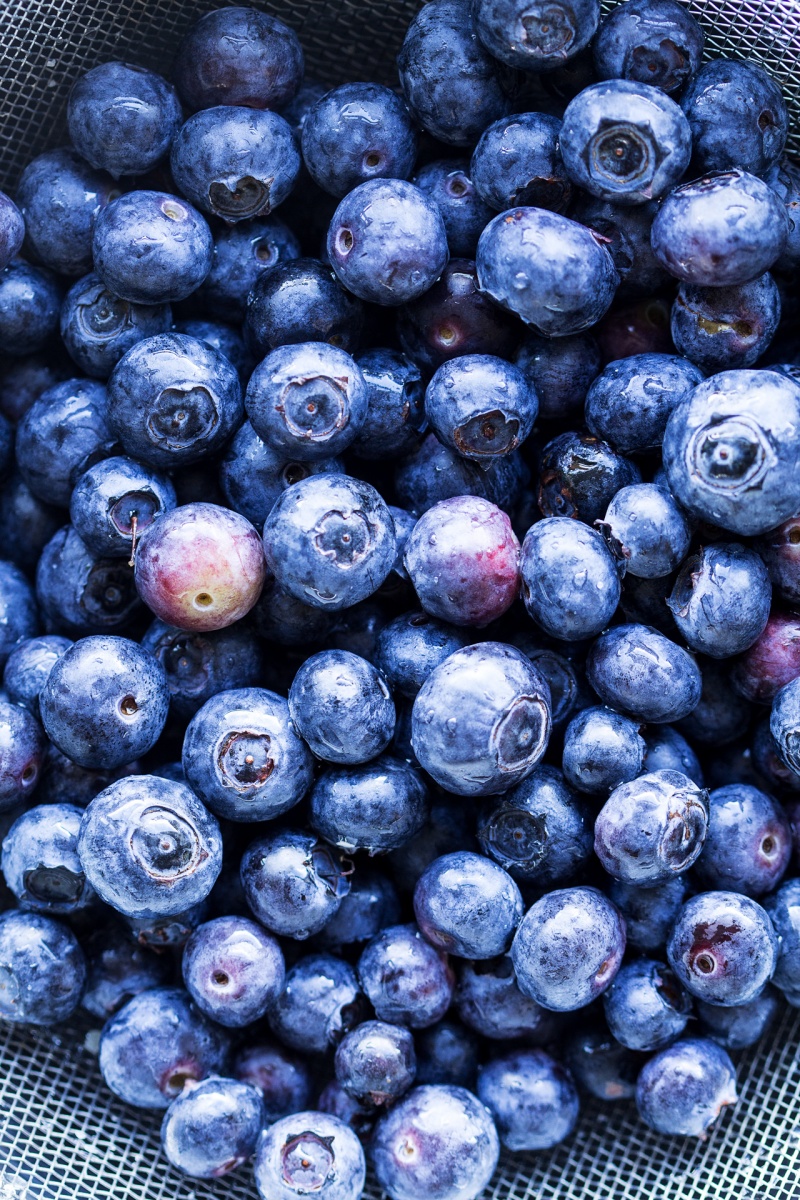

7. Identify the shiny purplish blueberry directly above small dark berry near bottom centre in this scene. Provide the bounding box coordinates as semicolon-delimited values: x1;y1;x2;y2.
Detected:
357;925;455;1030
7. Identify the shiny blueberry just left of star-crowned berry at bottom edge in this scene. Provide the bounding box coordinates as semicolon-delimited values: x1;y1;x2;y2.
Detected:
161;1075;264;1180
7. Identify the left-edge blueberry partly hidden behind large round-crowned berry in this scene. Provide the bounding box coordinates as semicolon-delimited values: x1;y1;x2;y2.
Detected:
2;804;94;917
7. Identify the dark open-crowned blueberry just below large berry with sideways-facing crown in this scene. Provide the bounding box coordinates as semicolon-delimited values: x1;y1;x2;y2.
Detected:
477;766;591;887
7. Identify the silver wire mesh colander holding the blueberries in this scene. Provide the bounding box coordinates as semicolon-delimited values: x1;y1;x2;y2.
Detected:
0;0;800;1200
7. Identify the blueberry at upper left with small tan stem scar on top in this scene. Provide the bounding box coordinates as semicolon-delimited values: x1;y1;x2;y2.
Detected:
92;192;213;304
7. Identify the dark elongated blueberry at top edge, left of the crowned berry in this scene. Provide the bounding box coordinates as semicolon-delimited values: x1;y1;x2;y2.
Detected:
397;0;511;146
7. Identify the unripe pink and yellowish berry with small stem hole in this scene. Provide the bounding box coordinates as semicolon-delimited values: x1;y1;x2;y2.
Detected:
134;503;266;632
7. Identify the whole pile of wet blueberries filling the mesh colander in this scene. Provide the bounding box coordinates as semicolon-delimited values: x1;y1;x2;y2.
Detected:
0;0;800;1200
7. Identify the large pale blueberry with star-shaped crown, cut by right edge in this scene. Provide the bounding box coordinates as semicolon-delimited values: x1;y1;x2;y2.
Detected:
663;371;800;536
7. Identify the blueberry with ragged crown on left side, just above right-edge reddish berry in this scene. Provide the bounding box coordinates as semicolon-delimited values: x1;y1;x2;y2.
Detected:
667;541;772;659
